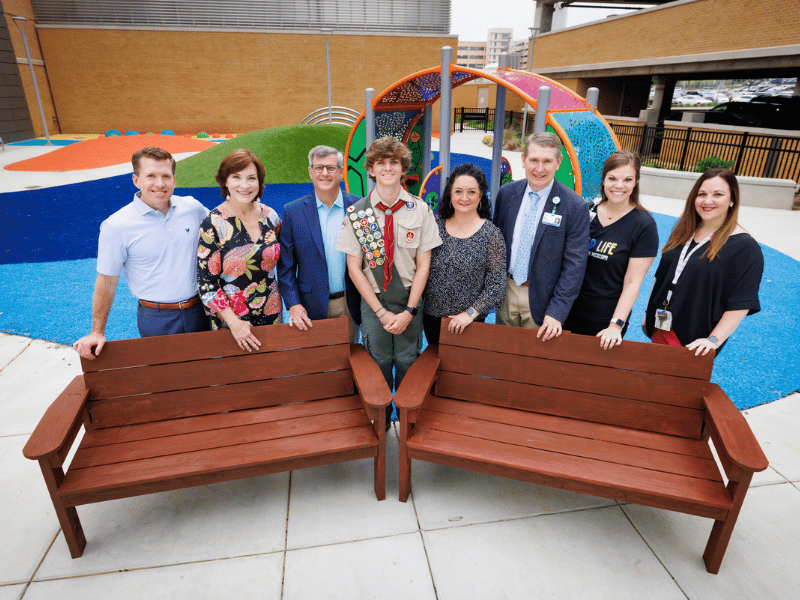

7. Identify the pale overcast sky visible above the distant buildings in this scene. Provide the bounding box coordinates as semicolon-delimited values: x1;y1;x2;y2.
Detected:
450;0;648;41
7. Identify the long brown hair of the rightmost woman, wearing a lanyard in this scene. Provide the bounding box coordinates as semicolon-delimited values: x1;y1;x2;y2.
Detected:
661;169;739;262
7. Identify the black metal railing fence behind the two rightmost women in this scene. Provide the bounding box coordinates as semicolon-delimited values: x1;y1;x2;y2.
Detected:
611;123;800;183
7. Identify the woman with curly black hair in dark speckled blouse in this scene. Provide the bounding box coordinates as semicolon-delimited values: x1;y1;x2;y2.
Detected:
422;164;506;344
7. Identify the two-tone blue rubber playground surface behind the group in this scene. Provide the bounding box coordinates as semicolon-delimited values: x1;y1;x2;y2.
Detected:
0;172;800;409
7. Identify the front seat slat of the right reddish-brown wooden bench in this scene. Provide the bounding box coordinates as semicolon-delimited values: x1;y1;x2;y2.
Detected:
408;428;733;519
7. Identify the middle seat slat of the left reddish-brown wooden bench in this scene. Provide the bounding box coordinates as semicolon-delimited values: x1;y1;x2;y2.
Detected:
70;407;370;469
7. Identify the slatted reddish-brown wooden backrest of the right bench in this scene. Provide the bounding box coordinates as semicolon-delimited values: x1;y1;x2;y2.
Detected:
434;319;713;439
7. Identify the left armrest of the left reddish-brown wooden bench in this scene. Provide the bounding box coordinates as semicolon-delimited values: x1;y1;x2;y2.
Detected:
22;375;89;466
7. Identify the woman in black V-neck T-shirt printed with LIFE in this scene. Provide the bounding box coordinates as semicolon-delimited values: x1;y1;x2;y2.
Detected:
564;150;658;350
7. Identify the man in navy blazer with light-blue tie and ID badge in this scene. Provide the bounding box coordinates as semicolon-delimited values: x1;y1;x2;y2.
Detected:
492;132;589;340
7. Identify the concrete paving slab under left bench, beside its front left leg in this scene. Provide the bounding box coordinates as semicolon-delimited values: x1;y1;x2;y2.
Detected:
36;473;289;580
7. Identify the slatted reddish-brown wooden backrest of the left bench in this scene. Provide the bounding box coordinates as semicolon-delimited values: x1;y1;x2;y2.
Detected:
81;317;354;428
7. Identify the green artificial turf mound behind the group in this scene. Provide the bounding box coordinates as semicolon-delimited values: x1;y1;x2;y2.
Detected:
175;125;350;188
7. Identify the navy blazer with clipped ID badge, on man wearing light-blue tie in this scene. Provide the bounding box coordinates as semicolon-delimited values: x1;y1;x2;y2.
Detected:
492;179;589;325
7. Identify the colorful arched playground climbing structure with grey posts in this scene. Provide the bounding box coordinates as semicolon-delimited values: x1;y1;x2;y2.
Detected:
345;46;619;207
